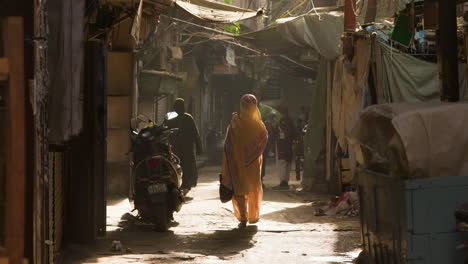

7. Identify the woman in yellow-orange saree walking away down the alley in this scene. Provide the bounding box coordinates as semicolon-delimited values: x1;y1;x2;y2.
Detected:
221;94;268;227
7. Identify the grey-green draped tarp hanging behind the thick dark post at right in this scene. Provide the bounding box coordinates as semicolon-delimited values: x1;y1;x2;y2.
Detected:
373;41;466;103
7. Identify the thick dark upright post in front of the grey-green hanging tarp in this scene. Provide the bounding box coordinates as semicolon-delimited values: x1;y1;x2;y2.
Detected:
438;0;460;102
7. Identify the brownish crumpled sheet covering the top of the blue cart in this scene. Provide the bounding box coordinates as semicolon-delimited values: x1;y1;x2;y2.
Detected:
352;103;468;178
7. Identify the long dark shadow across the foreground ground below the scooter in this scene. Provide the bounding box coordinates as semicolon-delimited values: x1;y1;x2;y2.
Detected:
65;226;258;263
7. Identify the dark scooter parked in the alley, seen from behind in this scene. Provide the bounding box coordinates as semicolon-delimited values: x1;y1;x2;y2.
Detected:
131;113;184;231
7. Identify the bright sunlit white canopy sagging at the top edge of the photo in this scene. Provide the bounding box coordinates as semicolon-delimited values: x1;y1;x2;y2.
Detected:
175;0;263;23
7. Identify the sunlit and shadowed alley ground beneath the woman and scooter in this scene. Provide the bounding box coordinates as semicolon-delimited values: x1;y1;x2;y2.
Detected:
65;166;360;264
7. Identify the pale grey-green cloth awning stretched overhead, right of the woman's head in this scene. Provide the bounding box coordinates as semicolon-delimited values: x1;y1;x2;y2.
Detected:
237;12;344;60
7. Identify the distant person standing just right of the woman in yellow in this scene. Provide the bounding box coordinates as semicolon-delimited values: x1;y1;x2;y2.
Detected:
273;105;296;189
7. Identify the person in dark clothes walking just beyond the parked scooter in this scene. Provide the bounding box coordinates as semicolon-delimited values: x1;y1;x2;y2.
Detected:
167;98;202;194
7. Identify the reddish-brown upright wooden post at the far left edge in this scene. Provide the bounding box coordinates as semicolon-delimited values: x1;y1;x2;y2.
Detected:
3;17;27;264
